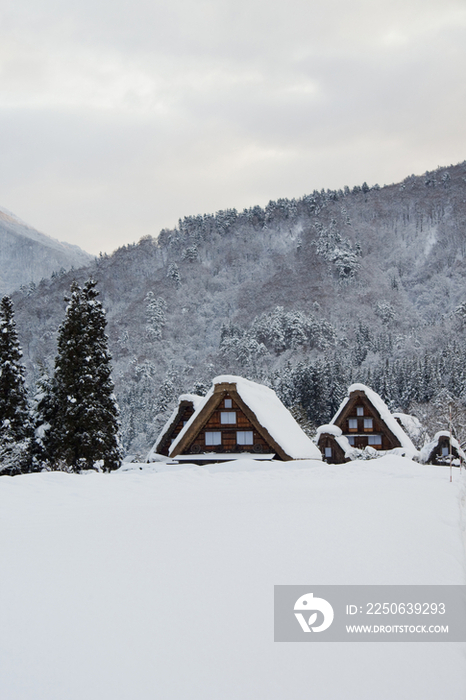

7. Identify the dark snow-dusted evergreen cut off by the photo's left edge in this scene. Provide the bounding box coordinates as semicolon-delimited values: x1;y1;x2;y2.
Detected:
0;296;32;474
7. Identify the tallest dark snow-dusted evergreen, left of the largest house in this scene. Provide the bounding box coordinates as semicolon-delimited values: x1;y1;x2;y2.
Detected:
44;280;121;471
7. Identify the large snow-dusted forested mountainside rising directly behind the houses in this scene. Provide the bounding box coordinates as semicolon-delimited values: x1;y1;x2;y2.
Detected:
14;162;466;450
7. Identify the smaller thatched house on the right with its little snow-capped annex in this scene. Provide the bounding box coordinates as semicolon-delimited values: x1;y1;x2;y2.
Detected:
318;384;418;464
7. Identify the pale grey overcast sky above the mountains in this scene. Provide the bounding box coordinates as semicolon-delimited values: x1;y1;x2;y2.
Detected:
0;0;466;253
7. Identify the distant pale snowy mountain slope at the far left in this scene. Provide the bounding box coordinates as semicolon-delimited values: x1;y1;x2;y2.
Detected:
0;209;92;294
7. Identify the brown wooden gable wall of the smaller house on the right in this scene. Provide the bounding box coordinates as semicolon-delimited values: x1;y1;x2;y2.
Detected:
335;391;401;450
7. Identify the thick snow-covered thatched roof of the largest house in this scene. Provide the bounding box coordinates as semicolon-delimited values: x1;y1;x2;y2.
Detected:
169;374;322;460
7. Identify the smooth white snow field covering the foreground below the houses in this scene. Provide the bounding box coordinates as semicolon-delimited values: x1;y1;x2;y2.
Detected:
0;456;466;700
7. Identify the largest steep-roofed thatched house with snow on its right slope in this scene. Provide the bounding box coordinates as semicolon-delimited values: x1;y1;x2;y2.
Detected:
169;375;321;464
